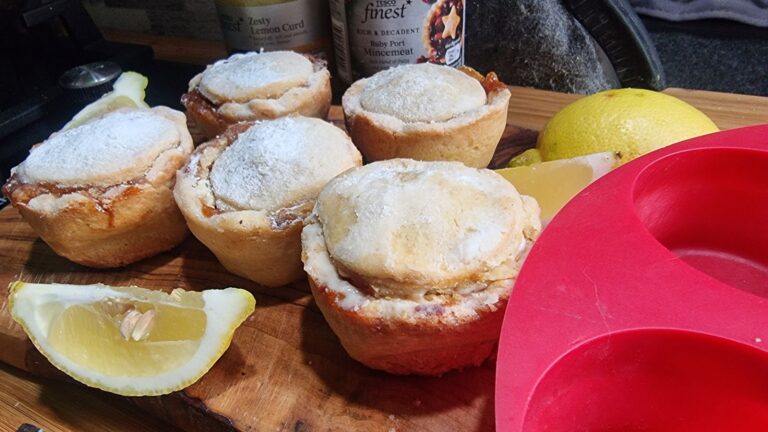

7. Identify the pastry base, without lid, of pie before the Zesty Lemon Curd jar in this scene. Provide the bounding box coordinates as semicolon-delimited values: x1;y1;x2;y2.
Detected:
181;58;331;140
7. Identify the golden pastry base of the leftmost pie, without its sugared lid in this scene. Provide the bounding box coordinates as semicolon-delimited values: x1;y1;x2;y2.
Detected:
4;108;192;268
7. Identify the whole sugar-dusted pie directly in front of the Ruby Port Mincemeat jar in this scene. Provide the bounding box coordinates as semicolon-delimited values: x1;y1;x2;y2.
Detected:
342;63;510;168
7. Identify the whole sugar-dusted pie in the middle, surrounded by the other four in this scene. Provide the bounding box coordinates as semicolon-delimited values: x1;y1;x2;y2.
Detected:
174;117;362;286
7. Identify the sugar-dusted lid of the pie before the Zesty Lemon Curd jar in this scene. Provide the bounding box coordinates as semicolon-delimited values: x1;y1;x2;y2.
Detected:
200;51;313;104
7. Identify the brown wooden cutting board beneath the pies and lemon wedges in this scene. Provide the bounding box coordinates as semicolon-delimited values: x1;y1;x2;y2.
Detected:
0;87;768;432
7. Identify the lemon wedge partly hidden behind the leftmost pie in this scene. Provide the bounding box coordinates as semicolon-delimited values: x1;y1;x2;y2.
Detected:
62;71;149;130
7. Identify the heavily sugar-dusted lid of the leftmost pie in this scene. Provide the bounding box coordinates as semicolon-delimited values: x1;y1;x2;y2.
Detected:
16;110;180;186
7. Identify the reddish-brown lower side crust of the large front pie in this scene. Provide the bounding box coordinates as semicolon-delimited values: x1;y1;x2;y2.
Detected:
309;274;513;376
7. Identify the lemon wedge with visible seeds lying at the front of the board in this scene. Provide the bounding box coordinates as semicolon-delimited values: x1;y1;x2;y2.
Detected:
10;282;255;396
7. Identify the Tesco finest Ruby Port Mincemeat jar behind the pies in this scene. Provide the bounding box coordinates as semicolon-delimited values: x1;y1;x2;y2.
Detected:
331;0;466;82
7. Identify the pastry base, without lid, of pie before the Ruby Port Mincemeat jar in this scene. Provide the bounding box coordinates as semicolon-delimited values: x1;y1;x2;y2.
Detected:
342;79;511;168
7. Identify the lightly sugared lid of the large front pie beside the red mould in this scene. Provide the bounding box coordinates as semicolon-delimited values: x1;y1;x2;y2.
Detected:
316;160;537;280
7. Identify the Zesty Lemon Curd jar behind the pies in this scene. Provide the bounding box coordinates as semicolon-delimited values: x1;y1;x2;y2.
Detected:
216;0;331;58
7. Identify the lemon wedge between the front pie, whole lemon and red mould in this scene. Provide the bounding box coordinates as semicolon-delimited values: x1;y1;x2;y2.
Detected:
496;152;619;223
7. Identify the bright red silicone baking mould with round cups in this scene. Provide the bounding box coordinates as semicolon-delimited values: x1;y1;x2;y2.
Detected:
496;125;768;432
